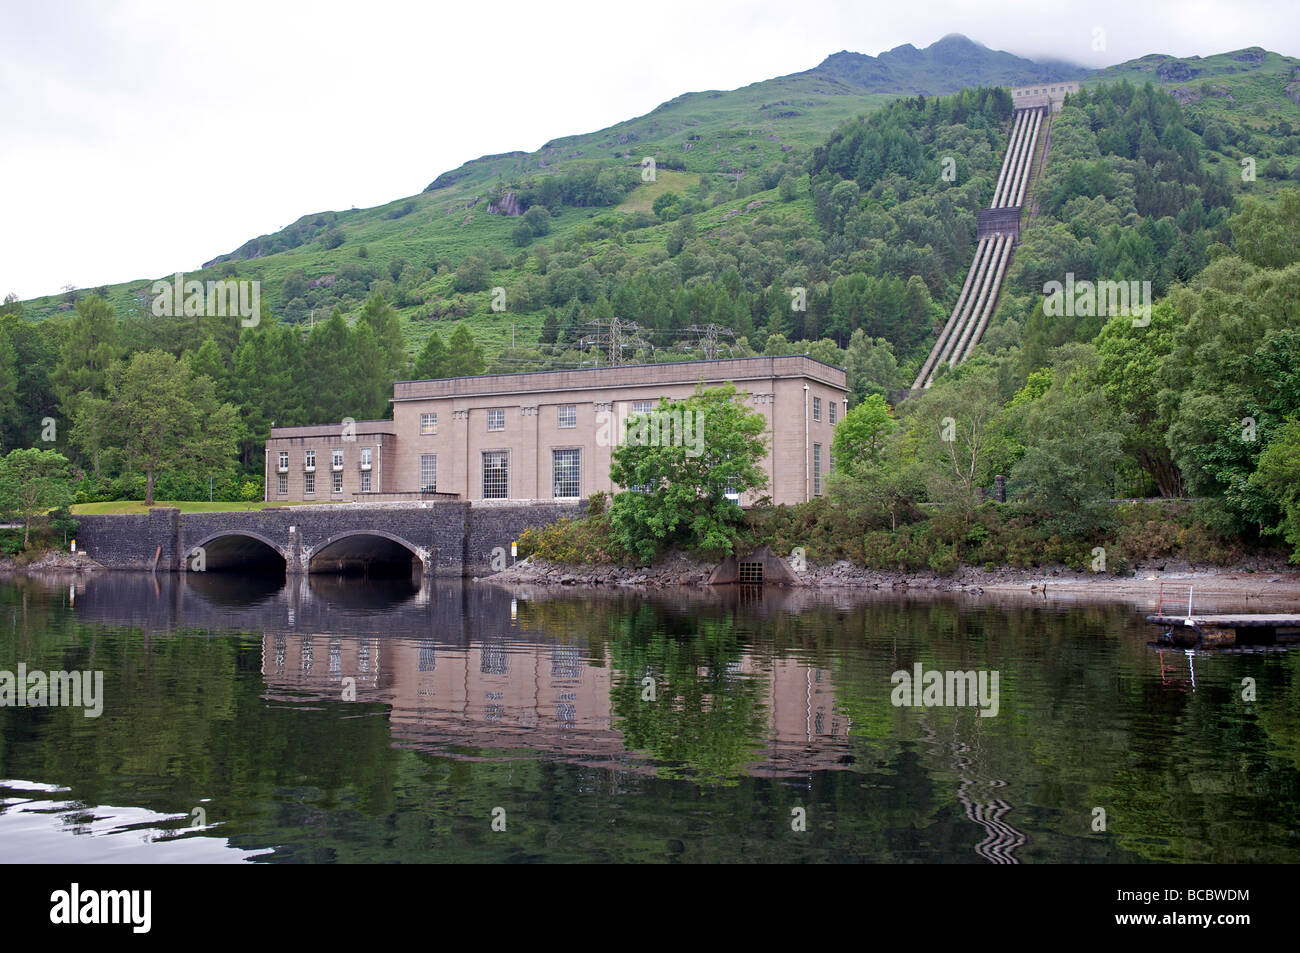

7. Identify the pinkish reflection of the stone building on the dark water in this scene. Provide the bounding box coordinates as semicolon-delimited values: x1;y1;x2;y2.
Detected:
263;632;850;775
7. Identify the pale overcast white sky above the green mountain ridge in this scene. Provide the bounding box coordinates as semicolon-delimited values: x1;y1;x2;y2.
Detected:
0;0;1300;298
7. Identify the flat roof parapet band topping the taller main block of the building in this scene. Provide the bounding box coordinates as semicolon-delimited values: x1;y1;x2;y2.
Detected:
393;354;848;402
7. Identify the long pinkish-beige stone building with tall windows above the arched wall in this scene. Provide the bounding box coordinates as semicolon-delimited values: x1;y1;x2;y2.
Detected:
267;355;848;503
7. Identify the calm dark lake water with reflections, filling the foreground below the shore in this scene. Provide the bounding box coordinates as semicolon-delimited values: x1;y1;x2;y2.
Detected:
0;573;1300;863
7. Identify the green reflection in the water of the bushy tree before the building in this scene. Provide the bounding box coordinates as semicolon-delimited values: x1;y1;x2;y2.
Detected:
610;605;767;784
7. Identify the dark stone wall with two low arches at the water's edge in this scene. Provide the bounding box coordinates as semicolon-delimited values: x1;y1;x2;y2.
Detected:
77;501;581;576
